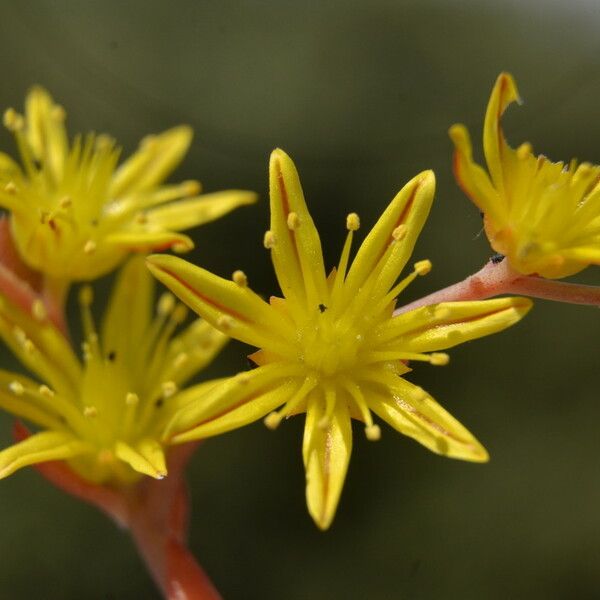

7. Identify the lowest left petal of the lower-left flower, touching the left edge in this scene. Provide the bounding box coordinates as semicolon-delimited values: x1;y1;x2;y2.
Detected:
0;431;90;479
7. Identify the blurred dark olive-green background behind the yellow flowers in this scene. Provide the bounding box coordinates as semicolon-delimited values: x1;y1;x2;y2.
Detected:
0;0;600;600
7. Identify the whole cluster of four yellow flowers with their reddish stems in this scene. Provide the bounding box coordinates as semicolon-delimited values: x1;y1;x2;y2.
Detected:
0;73;600;598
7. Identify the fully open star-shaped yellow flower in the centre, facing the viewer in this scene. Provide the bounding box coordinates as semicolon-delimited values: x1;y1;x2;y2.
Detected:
148;150;531;529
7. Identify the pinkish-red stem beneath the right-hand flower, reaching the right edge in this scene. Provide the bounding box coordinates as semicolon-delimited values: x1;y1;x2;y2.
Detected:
394;259;600;315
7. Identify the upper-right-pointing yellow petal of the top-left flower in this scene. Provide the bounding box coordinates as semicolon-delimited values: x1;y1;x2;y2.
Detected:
109;125;192;198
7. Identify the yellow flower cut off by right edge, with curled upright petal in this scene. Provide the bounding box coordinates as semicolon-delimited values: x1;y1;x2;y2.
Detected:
450;73;600;279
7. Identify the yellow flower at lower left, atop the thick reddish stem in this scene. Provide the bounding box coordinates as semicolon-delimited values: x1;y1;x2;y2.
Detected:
0;257;227;484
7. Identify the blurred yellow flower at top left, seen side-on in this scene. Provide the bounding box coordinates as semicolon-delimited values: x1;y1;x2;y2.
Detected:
0;87;255;281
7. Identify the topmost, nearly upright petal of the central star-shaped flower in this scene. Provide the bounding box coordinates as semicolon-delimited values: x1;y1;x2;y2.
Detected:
269;149;327;306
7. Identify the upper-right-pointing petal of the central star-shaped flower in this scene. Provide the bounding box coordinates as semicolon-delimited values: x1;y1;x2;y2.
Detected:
344;171;435;299
